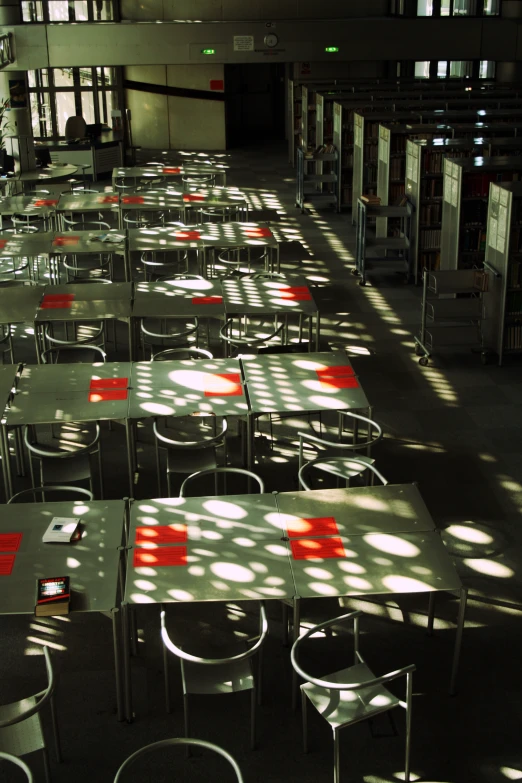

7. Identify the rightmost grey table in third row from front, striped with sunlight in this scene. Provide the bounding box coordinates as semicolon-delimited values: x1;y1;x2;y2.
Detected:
219;275;321;351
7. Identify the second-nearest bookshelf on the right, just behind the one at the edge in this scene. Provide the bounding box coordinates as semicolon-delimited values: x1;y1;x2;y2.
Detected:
440;155;522;269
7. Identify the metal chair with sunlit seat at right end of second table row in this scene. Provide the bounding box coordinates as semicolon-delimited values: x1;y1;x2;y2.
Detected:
298;411;386;489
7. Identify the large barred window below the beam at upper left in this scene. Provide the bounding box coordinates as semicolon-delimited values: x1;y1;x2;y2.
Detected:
28;67;118;138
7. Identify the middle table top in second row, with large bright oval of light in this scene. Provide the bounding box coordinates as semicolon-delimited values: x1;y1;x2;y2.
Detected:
129;359;248;419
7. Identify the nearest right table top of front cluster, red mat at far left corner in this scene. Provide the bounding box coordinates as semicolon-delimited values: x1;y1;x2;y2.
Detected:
290;532;462;598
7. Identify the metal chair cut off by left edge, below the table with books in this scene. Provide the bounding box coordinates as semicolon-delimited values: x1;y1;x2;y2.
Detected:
0;647;62;783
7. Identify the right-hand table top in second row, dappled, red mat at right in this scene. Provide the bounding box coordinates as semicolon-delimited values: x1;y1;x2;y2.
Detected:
241;351;369;413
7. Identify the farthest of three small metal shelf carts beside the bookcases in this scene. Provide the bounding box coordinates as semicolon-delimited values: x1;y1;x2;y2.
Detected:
295;145;339;213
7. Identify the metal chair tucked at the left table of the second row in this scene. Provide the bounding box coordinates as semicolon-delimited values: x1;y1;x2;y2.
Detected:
24;422;103;498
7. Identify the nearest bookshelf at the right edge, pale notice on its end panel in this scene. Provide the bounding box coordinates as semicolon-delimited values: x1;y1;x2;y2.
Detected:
484;182;522;365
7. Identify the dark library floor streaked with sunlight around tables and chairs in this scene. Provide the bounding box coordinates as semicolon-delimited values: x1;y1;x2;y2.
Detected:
0;144;522;783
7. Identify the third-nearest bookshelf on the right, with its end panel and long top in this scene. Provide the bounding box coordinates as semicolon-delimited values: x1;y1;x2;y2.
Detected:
405;137;522;283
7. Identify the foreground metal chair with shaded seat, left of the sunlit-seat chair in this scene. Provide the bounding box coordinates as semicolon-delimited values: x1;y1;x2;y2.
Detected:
161;602;268;749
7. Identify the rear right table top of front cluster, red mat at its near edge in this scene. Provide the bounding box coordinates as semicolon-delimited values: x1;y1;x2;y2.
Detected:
276;484;435;537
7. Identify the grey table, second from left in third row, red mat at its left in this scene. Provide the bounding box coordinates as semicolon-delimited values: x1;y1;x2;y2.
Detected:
34;283;134;364
